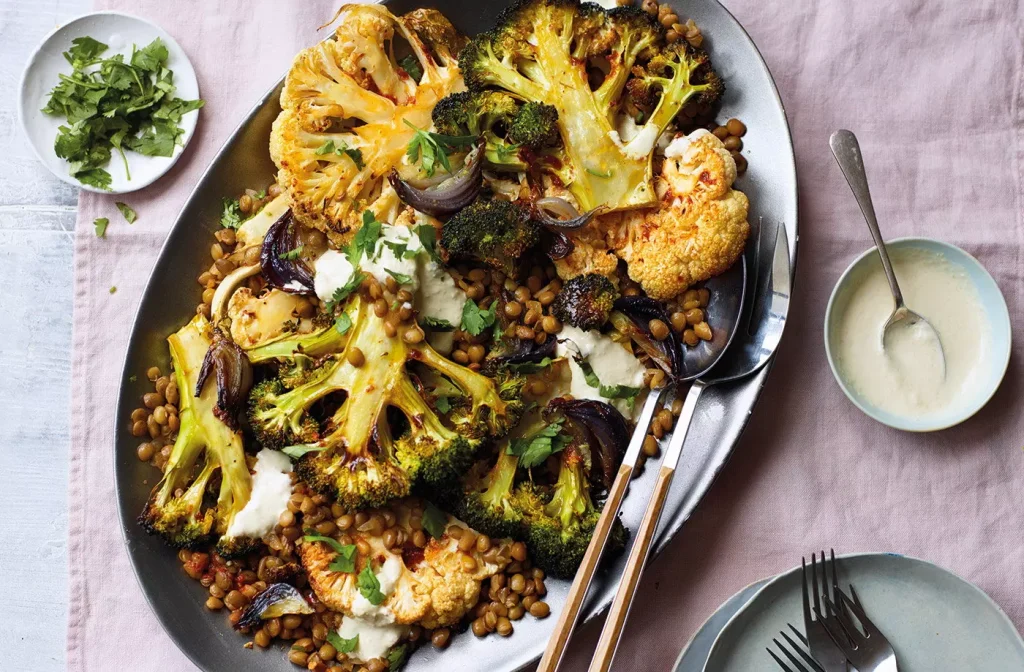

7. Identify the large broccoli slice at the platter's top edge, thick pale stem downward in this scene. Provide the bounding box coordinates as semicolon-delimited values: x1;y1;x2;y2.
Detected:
459;0;722;210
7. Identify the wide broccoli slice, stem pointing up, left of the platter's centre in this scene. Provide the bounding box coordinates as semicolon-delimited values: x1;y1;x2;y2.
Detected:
249;294;522;508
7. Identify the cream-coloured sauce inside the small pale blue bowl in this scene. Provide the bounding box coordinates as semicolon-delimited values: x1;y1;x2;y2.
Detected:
836;249;990;417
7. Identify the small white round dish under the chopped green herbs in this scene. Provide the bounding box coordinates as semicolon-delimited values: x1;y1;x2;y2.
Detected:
18;11;200;194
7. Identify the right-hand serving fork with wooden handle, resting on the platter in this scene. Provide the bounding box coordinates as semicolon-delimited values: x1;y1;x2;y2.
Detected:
590;224;791;672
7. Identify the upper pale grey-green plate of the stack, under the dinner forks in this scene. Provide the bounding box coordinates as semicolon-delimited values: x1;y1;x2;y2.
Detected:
704;553;1024;672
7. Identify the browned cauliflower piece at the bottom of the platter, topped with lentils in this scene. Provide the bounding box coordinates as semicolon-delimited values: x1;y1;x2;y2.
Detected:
299;502;508;628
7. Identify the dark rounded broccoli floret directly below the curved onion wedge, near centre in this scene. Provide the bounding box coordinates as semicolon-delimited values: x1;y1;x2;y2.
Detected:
441;199;541;277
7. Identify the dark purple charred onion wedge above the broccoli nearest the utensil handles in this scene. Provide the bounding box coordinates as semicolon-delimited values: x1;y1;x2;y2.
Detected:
548;396;630;489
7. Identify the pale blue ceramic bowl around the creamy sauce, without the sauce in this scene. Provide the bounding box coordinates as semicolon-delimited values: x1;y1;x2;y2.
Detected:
824;238;1011;431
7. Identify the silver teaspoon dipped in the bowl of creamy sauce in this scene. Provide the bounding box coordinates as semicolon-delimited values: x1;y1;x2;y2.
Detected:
828;130;946;379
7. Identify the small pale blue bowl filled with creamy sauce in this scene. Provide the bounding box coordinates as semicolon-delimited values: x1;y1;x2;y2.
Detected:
824;238;1011;431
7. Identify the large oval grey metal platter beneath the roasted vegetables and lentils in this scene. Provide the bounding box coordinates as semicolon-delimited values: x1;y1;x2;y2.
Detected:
115;0;797;672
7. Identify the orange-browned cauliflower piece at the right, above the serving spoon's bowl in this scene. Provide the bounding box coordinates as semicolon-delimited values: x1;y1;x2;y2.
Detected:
601;130;750;300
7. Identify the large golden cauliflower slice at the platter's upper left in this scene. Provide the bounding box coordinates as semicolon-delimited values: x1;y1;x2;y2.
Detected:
270;5;463;247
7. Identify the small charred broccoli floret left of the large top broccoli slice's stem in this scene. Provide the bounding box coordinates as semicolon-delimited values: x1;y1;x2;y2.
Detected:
433;91;560;172
